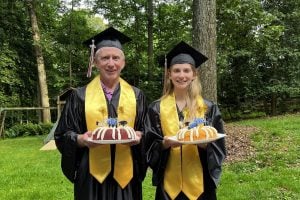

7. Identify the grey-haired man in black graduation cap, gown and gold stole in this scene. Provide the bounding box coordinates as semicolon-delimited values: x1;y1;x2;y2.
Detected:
55;27;147;200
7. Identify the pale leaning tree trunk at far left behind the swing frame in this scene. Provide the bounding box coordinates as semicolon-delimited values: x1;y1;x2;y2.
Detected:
27;0;51;123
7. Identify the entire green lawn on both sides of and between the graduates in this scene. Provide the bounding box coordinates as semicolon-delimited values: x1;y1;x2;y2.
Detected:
0;114;300;200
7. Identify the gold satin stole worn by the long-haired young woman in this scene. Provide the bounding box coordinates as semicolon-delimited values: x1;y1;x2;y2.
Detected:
160;94;205;199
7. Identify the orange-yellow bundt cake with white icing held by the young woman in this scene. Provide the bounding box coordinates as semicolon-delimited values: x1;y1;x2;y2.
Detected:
176;118;218;142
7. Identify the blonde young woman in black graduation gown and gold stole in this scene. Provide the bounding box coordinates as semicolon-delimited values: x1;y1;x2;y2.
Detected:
145;41;226;200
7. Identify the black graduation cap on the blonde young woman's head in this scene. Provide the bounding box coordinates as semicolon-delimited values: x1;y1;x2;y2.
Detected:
159;41;208;68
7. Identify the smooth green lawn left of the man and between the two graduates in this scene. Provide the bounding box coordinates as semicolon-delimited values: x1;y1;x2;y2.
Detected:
0;136;154;200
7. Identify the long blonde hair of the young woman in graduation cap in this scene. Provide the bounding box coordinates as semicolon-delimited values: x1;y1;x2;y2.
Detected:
161;65;207;121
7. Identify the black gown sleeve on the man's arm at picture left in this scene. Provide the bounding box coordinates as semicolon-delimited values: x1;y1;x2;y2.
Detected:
54;88;87;182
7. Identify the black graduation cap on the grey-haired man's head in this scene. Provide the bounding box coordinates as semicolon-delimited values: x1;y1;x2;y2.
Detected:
83;27;131;52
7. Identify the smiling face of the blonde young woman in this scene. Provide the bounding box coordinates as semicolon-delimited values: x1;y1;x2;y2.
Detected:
169;63;196;90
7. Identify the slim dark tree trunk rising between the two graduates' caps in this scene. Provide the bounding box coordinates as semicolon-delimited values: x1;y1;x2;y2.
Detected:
148;0;153;81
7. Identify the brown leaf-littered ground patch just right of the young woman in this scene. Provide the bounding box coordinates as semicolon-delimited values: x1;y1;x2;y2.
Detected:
225;124;258;163
